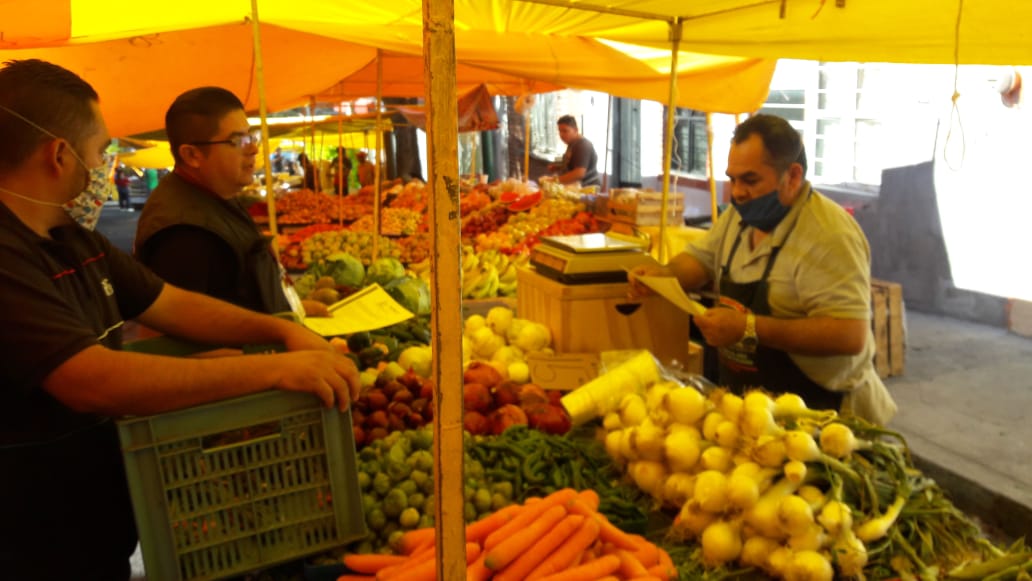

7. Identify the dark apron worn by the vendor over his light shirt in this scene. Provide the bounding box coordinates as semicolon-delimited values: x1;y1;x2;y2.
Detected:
719;226;843;410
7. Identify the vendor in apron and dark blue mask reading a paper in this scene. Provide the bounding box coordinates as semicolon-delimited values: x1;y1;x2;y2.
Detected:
632;115;896;423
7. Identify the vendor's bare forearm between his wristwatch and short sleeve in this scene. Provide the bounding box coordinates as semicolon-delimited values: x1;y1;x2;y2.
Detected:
756;316;869;356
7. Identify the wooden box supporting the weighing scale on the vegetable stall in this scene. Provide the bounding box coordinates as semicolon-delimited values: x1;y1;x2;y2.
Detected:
516;268;694;364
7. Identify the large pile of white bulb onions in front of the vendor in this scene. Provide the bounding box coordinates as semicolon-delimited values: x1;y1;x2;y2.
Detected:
603;382;904;581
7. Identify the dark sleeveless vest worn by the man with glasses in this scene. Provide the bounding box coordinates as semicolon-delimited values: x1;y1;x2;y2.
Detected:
134;172;291;314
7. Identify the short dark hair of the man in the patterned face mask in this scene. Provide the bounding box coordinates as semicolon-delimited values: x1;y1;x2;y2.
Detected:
0;59;100;169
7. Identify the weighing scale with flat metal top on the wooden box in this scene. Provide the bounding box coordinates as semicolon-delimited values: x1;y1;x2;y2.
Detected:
530;232;658;285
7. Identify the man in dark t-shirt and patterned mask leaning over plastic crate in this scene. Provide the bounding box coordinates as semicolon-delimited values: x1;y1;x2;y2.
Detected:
0;60;360;581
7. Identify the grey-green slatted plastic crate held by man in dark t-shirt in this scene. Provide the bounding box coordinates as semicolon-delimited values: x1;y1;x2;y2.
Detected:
118;338;365;581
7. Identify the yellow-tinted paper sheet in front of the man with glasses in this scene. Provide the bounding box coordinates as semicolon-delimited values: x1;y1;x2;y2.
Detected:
304;285;414;336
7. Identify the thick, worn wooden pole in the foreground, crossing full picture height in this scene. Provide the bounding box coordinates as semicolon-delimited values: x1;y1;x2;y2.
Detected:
423;0;465;580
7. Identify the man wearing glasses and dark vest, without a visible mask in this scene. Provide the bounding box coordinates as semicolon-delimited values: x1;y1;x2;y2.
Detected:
135;87;296;314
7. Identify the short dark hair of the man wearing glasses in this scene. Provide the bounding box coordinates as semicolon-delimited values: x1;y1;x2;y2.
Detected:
165;87;244;163
